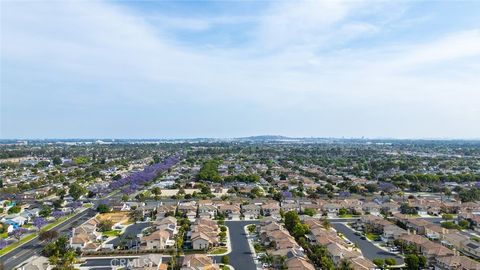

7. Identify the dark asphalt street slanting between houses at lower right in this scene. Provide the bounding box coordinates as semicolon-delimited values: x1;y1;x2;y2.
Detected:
332;223;403;264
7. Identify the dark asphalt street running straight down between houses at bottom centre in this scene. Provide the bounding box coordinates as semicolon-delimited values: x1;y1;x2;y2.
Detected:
213;220;258;270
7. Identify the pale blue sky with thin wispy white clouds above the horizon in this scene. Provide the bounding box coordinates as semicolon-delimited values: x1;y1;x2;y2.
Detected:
0;0;480;138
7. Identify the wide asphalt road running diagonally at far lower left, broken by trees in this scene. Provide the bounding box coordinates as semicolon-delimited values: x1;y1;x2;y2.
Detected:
0;209;95;269
